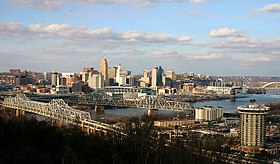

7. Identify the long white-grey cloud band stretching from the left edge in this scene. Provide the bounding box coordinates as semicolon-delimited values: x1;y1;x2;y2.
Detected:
0;23;191;46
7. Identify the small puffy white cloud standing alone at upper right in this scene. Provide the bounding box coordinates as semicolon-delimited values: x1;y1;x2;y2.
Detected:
209;27;244;37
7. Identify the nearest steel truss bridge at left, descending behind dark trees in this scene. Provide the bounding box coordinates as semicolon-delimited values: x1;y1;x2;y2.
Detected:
3;94;119;133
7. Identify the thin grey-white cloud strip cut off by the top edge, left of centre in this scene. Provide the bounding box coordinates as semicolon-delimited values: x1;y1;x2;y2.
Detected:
11;0;206;10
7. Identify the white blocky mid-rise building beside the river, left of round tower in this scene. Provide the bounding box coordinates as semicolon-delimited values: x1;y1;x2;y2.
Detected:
195;106;224;122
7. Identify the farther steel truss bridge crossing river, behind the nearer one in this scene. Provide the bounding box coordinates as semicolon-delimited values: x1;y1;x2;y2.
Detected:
75;91;193;111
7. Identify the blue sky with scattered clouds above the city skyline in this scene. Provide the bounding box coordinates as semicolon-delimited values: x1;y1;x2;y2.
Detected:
0;0;280;76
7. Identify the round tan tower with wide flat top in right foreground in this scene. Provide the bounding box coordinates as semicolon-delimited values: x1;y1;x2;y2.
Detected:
237;104;269;152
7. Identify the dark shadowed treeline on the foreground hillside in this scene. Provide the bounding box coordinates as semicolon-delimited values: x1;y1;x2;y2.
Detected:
0;117;223;164
